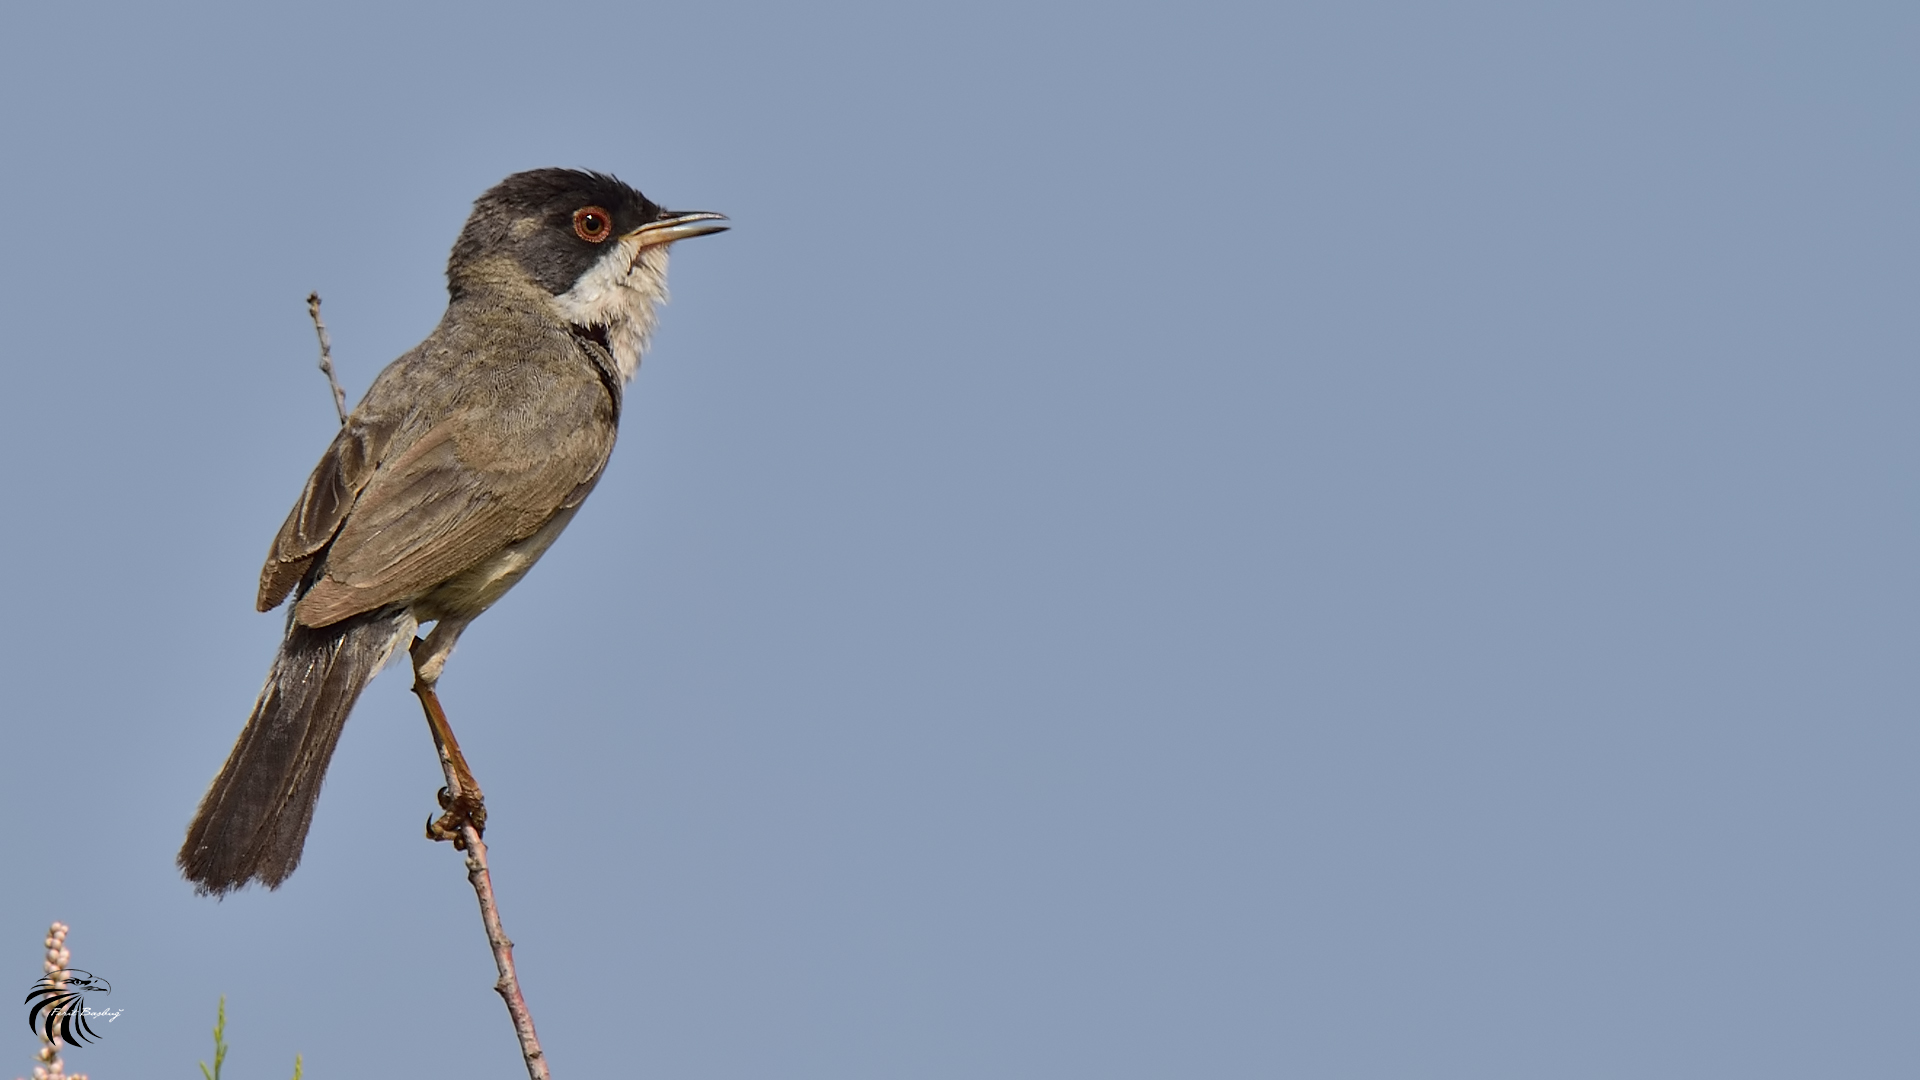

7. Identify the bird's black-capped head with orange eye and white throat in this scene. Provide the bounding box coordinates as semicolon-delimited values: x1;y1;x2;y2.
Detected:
447;169;726;379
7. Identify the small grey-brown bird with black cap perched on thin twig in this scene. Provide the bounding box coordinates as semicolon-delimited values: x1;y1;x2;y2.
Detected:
179;169;726;896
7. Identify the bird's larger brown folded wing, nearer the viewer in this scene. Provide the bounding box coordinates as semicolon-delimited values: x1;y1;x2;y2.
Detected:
296;401;614;626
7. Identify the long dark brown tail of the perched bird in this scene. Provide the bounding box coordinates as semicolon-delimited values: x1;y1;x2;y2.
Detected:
179;609;415;896
